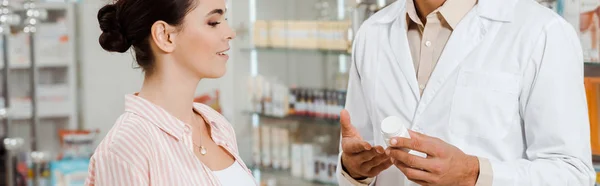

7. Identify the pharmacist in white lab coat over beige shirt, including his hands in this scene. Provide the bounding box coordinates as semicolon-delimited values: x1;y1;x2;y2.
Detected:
338;0;595;186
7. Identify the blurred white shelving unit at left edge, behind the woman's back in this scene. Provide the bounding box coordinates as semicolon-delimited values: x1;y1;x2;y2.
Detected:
0;2;78;154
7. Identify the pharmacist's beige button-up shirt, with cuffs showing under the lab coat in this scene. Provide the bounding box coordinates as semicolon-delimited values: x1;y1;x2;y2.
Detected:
342;0;493;186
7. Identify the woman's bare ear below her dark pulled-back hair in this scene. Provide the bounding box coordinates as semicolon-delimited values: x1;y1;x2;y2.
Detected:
150;21;177;53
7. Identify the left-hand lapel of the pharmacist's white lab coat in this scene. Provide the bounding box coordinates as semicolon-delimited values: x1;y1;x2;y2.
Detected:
389;12;420;100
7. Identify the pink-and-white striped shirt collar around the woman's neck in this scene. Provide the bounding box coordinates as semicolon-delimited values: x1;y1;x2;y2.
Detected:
125;93;217;140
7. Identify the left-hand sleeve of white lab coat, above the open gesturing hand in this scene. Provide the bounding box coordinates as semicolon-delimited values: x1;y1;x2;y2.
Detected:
336;25;375;186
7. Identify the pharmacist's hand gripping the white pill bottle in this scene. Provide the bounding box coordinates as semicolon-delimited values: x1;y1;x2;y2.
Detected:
386;130;479;186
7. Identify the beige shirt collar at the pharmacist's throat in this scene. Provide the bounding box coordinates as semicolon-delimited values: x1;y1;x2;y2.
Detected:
406;0;477;29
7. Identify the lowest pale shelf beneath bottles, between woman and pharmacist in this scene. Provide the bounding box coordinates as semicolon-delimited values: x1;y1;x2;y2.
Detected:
253;169;335;186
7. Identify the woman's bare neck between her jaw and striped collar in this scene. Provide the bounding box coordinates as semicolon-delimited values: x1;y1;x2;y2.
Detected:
138;62;200;124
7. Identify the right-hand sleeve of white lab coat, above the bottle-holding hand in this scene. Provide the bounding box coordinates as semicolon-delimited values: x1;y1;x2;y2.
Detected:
491;18;595;186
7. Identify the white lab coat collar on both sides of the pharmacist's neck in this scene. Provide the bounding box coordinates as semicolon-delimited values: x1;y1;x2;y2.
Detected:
373;0;518;24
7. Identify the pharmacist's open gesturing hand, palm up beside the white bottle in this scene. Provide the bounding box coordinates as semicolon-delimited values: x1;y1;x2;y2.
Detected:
340;110;392;179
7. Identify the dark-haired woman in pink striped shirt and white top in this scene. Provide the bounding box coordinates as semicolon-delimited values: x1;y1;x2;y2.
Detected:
86;0;256;186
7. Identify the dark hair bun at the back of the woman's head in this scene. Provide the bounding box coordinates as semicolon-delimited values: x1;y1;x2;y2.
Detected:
98;4;131;53
